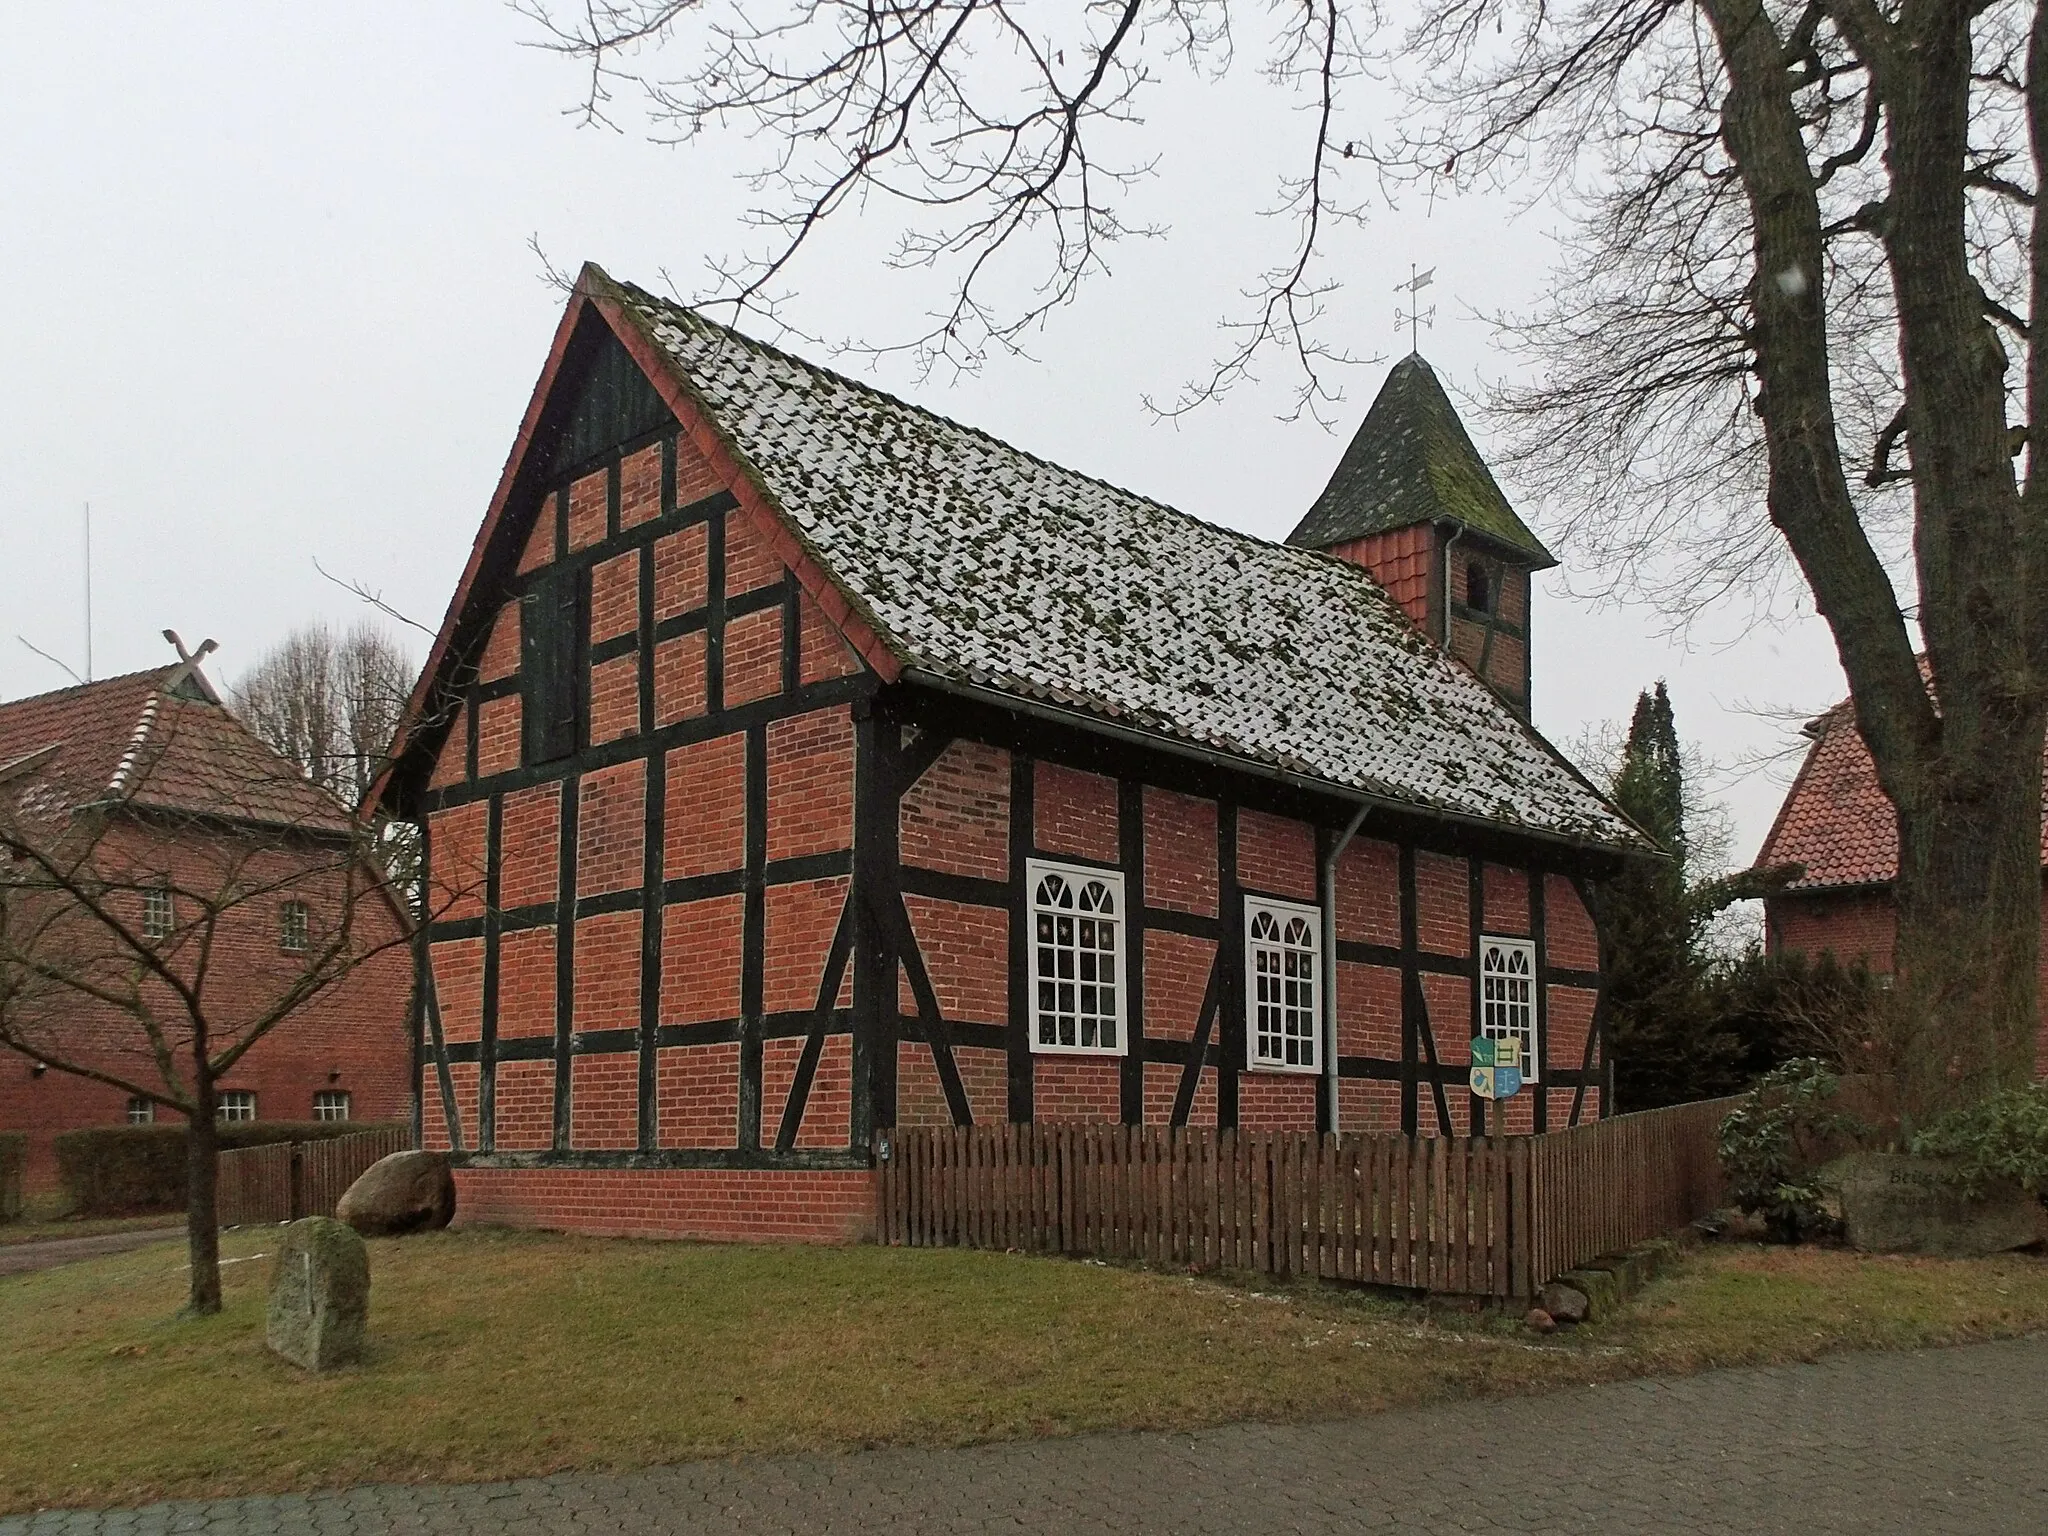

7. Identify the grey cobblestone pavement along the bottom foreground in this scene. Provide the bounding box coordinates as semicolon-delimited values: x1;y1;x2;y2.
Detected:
0;1337;2048;1536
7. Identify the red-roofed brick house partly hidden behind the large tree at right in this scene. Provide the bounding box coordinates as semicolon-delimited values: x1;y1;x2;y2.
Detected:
1757;684;2048;1075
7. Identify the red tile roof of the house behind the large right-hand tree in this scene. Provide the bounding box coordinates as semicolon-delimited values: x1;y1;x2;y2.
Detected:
1757;700;2048;891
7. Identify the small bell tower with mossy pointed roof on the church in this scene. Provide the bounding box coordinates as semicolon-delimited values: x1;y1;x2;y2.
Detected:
1286;352;1556;719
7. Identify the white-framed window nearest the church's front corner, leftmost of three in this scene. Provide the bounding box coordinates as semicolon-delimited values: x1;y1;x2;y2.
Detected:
1024;858;1124;1057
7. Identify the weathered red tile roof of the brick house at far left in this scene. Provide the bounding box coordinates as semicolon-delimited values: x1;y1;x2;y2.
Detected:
0;664;352;834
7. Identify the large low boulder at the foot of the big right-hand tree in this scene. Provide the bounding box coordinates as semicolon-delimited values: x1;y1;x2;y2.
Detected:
1819;1153;2048;1260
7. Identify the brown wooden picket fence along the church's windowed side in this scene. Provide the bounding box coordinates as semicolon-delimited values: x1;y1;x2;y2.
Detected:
874;1100;1733;1296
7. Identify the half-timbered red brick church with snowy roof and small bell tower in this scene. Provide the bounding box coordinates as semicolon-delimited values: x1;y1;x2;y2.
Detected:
379;268;1645;1239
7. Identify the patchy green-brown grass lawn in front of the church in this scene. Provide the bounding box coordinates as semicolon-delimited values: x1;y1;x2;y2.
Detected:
0;1231;2048;1513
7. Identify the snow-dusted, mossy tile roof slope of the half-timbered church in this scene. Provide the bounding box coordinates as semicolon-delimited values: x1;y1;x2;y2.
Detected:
621;285;1645;848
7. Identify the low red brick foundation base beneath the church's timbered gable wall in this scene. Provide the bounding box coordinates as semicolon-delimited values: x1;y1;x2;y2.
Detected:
455;1167;874;1243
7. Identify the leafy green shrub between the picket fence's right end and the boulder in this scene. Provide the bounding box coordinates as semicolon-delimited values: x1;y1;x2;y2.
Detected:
1720;1057;1864;1243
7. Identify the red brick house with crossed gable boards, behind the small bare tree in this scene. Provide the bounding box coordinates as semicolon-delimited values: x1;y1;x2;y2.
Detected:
0;662;416;1192
